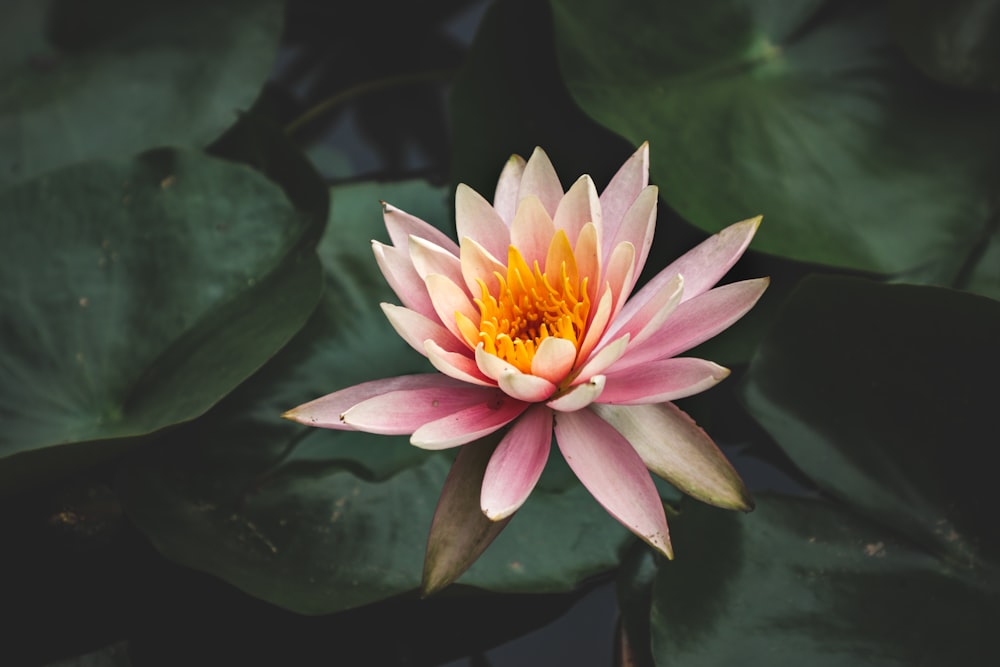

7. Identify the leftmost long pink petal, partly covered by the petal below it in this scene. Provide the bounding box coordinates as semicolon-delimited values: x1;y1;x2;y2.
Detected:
282;373;467;431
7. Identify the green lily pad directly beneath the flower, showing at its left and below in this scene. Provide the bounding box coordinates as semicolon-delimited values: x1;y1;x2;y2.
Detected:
118;183;630;614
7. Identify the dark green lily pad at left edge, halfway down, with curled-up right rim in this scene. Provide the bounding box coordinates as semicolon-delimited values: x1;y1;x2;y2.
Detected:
0;150;321;491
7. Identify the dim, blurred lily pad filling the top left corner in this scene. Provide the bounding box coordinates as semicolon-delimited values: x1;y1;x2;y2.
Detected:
0;0;283;184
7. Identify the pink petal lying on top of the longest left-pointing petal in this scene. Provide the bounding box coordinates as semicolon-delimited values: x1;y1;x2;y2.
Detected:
340;383;505;435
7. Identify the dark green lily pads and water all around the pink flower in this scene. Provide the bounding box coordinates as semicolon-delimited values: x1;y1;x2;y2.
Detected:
0;0;1000;667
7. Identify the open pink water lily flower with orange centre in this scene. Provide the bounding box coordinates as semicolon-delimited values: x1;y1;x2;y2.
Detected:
286;144;768;588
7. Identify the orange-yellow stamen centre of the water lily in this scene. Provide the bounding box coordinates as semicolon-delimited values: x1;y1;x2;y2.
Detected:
458;230;590;373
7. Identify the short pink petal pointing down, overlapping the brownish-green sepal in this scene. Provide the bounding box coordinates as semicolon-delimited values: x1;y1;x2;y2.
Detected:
480;405;552;521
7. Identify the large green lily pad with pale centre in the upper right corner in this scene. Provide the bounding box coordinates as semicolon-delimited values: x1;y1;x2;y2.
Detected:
551;0;1000;284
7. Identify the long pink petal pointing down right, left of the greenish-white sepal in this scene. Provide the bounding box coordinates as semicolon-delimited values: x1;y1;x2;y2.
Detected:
555;410;673;558
